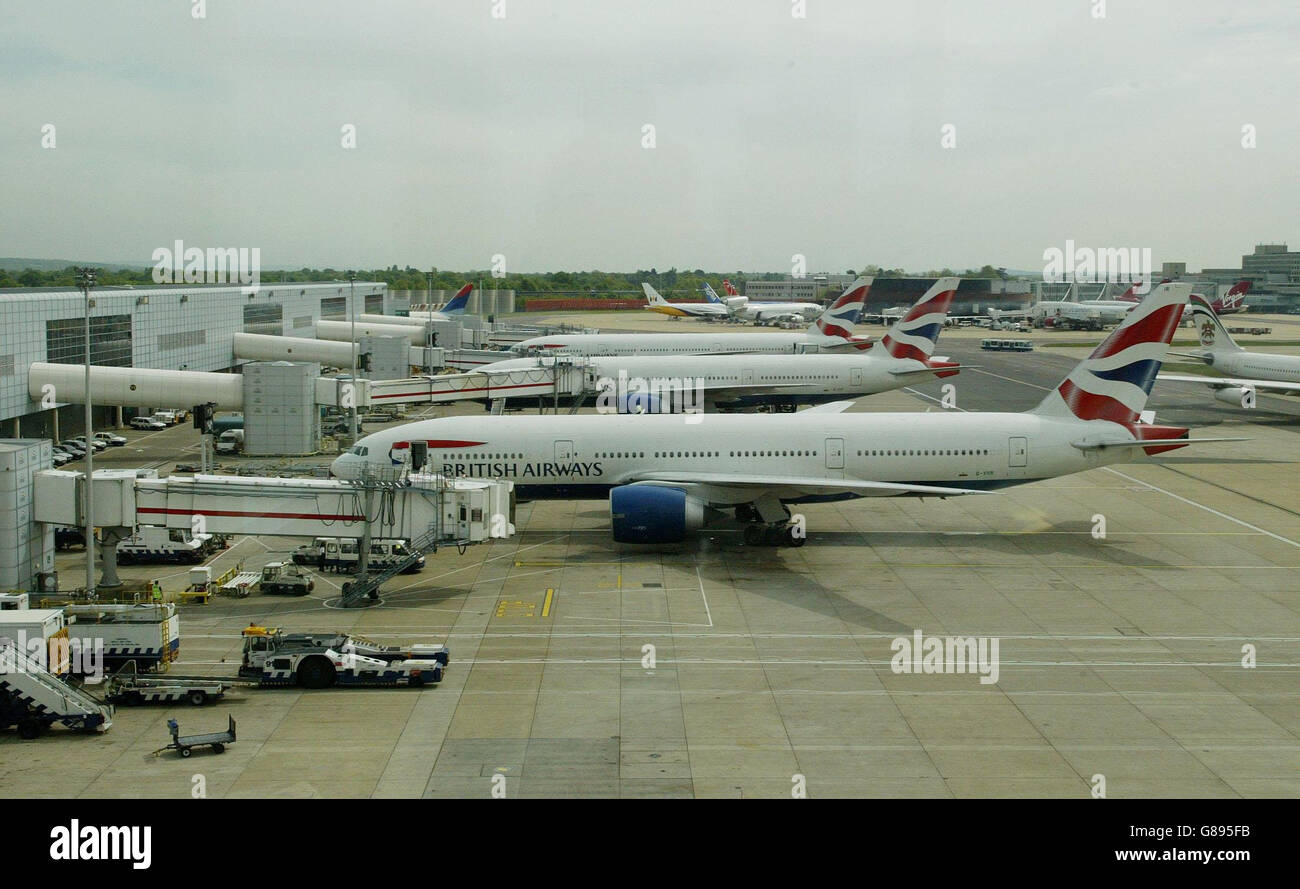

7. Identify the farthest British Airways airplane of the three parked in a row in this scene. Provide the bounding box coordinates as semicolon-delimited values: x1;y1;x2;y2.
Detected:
510;277;872;355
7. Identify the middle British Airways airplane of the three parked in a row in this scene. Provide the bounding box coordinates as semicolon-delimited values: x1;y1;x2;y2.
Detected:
484;278;961;412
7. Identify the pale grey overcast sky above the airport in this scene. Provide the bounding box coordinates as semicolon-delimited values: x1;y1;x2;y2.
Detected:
0;0;1300;272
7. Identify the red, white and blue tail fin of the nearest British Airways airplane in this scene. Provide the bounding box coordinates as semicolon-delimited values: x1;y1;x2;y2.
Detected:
1034;283;1192;423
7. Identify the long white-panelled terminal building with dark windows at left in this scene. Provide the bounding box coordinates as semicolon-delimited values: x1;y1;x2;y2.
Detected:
0;281;384;438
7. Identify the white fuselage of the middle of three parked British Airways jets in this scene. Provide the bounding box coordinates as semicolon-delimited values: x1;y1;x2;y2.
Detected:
484;350;951;404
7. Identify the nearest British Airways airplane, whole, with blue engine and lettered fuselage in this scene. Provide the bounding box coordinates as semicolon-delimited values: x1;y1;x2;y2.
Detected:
332;283;1232;546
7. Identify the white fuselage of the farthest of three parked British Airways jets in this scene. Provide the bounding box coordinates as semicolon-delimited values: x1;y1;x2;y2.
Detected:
510;331;868;355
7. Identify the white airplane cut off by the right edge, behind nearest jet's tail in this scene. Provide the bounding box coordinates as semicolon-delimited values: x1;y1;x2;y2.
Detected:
1160;294;1300;411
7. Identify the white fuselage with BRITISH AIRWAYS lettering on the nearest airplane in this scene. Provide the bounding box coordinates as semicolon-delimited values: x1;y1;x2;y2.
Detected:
332;412;1135;503
